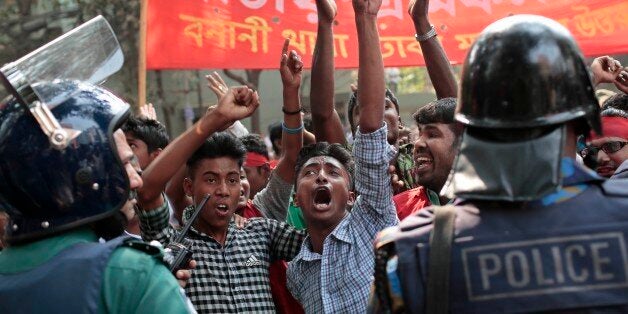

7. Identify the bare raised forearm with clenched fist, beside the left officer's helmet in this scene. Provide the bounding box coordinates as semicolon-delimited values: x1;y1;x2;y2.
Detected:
138;87;259;210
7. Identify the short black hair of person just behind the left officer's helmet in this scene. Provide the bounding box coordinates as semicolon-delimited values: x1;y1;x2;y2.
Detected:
122;116;170;153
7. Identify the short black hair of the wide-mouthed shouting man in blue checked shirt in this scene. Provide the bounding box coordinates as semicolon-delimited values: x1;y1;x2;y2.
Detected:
294;142;355;190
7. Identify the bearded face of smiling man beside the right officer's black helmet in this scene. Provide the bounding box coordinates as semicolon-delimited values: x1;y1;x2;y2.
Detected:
413;123;456;193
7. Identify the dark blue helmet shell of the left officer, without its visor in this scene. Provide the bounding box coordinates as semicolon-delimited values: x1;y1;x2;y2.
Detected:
0;81;129;242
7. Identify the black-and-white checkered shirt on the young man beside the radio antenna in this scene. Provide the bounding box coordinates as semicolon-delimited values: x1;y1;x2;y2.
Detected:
138;203;305;313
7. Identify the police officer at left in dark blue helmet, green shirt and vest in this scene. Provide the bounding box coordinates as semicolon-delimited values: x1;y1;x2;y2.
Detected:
0;20;194;313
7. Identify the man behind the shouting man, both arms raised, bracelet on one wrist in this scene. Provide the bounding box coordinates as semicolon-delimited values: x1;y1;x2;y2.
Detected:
310;0;457;193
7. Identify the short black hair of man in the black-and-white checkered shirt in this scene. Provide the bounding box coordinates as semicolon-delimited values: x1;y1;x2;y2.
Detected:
185;132;246;178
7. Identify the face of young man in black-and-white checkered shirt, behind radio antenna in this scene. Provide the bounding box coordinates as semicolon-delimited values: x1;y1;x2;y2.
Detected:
183;157;241;231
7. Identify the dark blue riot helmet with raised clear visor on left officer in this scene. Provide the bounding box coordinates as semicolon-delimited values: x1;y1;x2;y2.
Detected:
0;17;130;243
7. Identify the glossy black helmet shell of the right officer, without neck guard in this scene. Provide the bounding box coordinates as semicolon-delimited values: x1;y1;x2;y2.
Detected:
456;15;600;133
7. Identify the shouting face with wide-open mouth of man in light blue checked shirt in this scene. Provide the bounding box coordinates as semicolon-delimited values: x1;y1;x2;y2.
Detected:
295;156;353;228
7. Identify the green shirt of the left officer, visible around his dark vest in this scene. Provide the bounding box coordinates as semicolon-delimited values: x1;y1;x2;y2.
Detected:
0;228;193;313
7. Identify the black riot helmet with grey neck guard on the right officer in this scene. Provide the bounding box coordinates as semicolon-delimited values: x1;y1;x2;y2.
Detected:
442;15;600;202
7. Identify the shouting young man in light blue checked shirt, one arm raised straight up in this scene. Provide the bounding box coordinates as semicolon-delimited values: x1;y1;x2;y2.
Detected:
288;0;397;313
